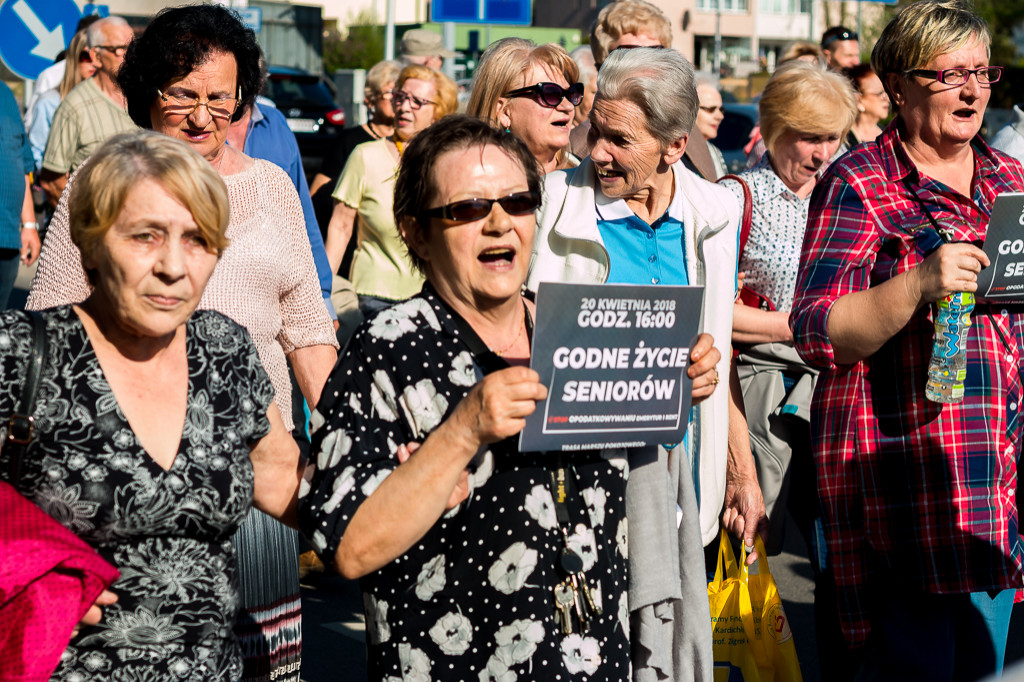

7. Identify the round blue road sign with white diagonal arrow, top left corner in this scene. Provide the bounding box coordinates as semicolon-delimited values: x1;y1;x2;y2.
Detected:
0;0;82;80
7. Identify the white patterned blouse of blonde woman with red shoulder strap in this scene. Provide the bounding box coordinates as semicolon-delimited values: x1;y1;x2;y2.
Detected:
723;154;811;312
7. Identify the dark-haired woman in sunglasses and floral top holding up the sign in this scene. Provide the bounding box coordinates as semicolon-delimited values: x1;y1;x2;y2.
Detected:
300;116;692;680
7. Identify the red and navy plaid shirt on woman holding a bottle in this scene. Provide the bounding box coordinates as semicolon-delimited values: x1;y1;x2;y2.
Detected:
790;122;1024;645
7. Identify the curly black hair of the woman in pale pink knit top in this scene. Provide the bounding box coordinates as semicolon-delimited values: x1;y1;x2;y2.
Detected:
118;4;265;128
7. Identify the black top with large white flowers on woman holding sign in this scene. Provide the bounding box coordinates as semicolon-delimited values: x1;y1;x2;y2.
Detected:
299;285;630;682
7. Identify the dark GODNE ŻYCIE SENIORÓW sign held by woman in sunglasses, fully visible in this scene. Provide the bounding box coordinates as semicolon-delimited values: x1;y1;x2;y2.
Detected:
519;283;703;452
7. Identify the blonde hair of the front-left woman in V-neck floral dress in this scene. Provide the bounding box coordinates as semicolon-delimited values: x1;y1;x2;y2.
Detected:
68;130;230;274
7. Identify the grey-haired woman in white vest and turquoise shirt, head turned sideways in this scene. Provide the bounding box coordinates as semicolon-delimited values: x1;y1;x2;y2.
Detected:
527;47;764;679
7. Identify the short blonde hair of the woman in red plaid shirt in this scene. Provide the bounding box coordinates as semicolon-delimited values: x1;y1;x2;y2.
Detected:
871;0;992;104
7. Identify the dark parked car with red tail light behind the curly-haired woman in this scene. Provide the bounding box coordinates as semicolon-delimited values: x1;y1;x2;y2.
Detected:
263;67;345;178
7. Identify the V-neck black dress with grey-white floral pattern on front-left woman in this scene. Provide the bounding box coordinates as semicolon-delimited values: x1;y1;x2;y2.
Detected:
0;306;273;682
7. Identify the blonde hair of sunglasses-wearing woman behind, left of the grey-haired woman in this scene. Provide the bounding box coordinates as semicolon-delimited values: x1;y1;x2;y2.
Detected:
466;38;580;125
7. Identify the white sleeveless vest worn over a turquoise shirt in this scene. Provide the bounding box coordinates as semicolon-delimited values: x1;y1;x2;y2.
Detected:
526;158;742;545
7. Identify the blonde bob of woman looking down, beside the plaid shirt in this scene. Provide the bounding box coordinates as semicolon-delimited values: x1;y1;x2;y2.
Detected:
758;60;857;155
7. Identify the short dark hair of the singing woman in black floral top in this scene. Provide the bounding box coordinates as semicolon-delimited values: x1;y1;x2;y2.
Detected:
394;114;543;271
